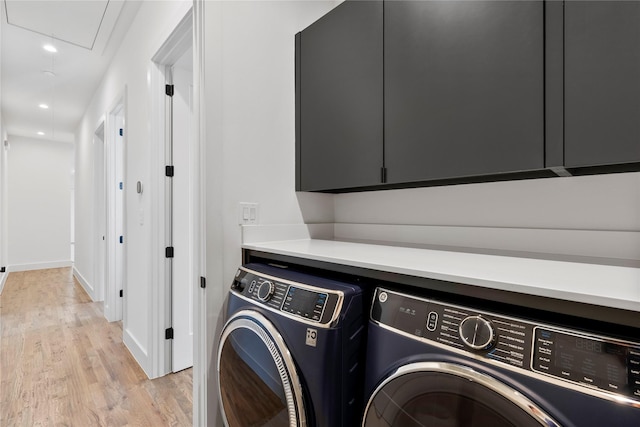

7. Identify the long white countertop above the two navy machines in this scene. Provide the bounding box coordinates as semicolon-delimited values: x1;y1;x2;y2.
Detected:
242;239;640;311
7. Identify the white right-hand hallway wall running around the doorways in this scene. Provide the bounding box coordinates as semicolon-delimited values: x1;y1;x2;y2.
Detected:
75;0;191;375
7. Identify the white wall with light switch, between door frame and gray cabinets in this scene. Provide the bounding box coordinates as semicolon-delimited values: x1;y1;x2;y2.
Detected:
201;1;339;425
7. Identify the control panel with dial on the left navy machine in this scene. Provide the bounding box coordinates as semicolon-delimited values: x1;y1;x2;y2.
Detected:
231;268;341;324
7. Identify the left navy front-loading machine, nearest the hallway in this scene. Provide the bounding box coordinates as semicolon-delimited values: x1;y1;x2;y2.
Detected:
217;264;366;427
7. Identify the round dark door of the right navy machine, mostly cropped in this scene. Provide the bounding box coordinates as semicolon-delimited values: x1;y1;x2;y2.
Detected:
362;362;559;427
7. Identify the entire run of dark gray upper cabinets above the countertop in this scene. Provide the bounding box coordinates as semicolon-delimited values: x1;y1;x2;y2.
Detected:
296;0;640;192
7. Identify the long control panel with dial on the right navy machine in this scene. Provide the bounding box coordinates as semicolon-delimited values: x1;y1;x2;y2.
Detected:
371;288;640;402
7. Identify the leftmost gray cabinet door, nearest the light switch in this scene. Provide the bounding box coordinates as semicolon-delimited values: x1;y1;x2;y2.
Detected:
296;1;383;191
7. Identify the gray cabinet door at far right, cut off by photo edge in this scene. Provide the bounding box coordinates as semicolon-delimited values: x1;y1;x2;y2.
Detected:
564;1;640;167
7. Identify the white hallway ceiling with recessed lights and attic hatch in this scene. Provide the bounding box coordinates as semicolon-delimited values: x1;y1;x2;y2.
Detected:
0;0;140;143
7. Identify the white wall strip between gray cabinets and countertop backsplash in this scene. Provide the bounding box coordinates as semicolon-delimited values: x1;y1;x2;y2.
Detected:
335;173;640;231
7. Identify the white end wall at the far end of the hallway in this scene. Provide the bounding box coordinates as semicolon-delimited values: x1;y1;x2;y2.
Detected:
7;136;73;271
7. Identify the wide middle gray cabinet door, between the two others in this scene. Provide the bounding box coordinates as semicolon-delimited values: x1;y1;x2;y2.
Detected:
384;1;544;183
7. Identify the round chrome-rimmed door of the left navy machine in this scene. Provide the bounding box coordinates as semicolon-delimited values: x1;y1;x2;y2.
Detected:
218;310;306;427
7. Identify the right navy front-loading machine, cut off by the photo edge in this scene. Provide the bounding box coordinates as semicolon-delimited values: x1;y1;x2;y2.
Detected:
362;288;640;427
